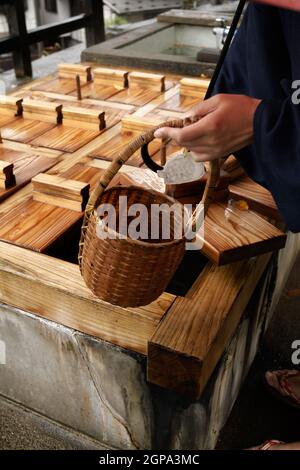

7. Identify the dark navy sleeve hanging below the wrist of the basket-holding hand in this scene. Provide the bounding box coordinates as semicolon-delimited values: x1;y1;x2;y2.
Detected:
254;97;300;232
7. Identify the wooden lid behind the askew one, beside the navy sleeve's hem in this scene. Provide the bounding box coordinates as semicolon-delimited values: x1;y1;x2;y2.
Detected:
229;176;281;220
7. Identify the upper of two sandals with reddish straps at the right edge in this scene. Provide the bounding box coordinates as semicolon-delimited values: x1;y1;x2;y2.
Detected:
264;370;300;410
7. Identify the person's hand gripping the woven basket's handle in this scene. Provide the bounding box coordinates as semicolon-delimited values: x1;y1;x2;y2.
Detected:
154;94;261;161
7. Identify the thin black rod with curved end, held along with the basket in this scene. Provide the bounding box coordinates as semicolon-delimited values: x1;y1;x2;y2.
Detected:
141;0;247;173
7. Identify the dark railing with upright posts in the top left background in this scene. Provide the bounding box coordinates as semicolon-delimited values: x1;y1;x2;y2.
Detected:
0;0;105;77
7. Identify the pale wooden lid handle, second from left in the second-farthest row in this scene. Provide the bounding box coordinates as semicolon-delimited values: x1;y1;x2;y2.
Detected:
23;98;63;124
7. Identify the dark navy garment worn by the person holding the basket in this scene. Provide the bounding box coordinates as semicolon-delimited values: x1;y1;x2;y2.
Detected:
215;5;300;232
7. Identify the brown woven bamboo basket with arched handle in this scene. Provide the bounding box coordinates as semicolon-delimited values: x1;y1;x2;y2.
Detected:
79;119;218;307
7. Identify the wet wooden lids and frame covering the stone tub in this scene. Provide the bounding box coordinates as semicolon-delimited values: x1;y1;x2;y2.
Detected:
0;62;285;398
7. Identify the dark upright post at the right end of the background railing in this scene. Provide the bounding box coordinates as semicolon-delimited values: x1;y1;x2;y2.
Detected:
86;0;105;47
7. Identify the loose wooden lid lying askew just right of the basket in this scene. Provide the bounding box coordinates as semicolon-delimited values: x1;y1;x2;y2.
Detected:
199;202;286;265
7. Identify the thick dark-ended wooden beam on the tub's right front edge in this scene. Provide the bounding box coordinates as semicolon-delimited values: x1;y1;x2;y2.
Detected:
148;255;270;400
